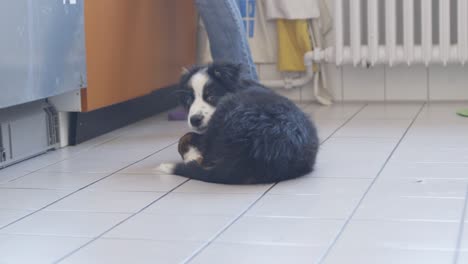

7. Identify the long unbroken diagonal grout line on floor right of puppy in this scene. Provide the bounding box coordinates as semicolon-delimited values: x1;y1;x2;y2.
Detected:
316;103;426;264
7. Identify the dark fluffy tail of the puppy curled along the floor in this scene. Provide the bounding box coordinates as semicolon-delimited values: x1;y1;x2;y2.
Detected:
174;161;269;184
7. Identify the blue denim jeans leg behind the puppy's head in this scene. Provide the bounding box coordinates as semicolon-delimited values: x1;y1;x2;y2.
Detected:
195;0;258;80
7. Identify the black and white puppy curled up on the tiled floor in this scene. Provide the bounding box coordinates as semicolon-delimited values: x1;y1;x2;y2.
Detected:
158;64;319;184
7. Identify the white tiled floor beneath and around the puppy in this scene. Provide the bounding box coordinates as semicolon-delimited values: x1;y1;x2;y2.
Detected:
0;103;468;264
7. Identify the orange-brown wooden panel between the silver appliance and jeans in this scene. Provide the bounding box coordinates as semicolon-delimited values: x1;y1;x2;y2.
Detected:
83;0;196;111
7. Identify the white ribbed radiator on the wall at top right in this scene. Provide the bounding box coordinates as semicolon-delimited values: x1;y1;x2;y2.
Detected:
308;0;468;66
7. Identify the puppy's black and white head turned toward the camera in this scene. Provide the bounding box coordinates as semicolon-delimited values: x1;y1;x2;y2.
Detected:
176;63;241;133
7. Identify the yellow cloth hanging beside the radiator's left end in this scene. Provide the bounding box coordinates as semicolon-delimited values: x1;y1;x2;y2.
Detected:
277;19;312;71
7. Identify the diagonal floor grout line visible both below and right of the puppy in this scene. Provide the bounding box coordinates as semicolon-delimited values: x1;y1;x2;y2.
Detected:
182;104;368;264
